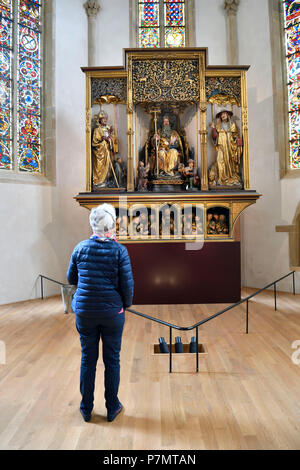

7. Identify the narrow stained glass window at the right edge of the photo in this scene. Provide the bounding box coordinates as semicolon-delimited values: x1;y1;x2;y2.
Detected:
283;0;300;169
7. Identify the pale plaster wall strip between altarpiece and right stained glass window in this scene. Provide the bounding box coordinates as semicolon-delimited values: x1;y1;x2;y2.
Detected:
238;0;282;287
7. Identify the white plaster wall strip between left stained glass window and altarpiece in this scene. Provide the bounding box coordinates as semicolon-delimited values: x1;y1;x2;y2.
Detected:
52;0;89;275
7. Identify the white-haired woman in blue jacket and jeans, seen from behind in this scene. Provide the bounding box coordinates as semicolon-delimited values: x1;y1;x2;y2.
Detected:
67;204;133;421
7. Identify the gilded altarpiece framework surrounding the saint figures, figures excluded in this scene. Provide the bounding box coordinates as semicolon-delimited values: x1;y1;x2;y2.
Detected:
75;48;260;243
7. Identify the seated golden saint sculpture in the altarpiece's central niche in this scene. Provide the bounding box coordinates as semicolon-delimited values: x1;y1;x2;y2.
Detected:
151;116;183;176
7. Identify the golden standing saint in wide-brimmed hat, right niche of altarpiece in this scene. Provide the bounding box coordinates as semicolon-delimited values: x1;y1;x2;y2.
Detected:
208;109;243;187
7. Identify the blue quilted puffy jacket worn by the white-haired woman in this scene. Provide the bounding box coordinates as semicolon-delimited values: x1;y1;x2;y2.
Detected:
67;237;133;318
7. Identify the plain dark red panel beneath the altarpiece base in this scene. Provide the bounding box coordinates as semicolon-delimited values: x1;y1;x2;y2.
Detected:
126;242;241;305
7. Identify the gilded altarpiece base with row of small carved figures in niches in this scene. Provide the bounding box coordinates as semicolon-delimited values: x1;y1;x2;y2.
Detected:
75;191;259;244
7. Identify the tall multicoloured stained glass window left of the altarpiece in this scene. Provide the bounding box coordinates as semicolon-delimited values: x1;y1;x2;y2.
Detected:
0;0;42;173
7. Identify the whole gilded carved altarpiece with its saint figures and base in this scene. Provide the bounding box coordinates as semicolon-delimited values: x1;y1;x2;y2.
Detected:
76;48;259;243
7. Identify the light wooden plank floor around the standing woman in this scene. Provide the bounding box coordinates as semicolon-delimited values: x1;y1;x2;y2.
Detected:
0;289;300;450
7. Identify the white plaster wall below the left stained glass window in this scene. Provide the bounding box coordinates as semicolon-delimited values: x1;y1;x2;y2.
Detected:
0;183;59;304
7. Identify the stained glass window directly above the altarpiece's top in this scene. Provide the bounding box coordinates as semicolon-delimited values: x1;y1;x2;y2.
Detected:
138;0;185;47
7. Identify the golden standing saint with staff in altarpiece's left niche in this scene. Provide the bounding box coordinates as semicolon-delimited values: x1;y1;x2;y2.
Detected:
92;111;119;188
